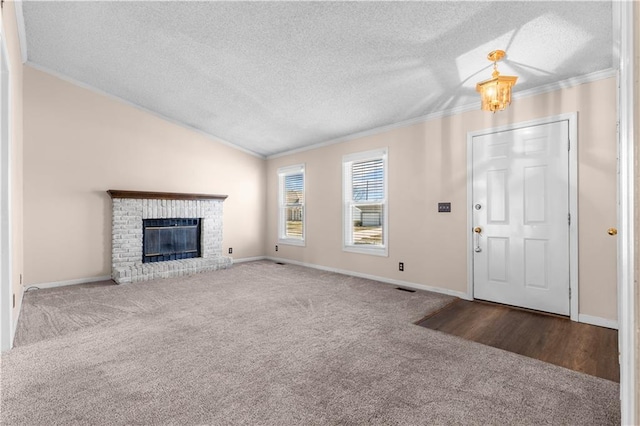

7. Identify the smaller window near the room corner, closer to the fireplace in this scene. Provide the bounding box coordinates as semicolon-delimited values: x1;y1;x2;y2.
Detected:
278;164;305;246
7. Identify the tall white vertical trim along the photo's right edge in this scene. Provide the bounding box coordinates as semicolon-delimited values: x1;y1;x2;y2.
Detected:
614;2;640;424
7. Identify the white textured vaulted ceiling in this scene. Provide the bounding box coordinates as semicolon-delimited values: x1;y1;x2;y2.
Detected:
23;0;614;156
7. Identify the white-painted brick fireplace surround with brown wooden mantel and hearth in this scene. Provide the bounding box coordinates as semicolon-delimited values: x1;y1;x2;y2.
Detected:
107;189;233;284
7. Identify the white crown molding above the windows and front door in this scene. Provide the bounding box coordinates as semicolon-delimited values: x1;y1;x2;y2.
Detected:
266;69;616;160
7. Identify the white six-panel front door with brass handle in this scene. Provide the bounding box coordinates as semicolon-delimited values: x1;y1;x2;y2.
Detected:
471;120;570;315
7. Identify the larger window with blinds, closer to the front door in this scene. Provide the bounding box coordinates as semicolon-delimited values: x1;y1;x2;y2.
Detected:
342;149;387;256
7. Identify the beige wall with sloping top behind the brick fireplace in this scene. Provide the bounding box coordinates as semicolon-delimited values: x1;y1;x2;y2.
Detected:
24;66;265;285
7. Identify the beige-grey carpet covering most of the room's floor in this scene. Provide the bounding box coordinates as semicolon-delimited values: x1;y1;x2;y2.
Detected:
0;261;620;425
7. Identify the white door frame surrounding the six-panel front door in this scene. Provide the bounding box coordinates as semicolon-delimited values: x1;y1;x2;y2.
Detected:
467;112;578;321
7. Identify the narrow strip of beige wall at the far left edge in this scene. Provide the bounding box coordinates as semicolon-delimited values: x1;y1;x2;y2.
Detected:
2;1;23;330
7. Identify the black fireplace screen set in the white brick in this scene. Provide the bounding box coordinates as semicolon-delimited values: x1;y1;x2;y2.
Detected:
142;219;200;263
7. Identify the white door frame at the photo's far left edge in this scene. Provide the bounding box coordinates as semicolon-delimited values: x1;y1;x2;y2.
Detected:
0;16;14;351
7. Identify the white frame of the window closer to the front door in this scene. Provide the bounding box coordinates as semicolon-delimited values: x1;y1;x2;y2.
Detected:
342;148;389;257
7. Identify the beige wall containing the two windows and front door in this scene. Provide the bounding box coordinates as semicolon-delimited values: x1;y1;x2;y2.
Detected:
265;78;617;320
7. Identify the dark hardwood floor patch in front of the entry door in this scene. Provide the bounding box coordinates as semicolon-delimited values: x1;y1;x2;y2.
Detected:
416;300;620;382
